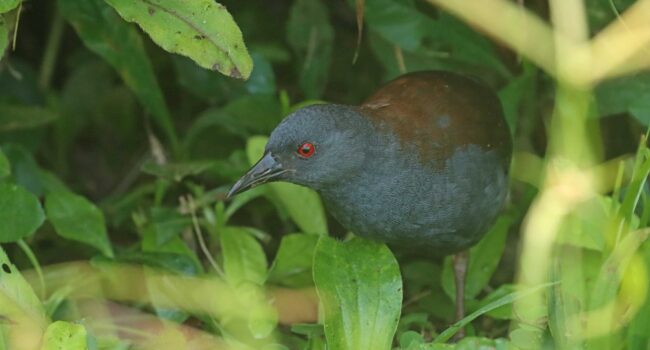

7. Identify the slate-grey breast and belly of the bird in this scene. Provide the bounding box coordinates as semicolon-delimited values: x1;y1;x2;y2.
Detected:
321;146;507;252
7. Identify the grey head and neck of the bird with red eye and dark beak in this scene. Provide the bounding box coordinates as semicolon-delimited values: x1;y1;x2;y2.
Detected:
228;104;370;197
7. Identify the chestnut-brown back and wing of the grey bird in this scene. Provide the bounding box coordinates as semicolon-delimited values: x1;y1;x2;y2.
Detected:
360;71;512;167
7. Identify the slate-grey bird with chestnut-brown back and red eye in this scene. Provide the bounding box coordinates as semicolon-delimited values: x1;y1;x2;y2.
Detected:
229;71;512;330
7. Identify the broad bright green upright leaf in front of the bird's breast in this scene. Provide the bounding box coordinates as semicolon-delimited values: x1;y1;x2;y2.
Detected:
314;236;402;350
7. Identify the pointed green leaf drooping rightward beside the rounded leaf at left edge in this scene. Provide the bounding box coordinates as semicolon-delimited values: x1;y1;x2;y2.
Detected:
45;192;113;257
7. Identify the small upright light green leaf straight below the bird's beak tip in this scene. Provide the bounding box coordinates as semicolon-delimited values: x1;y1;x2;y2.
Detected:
220;226;267;286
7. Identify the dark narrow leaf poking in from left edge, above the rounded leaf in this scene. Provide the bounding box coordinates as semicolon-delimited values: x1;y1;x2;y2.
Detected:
0;104;58;132
